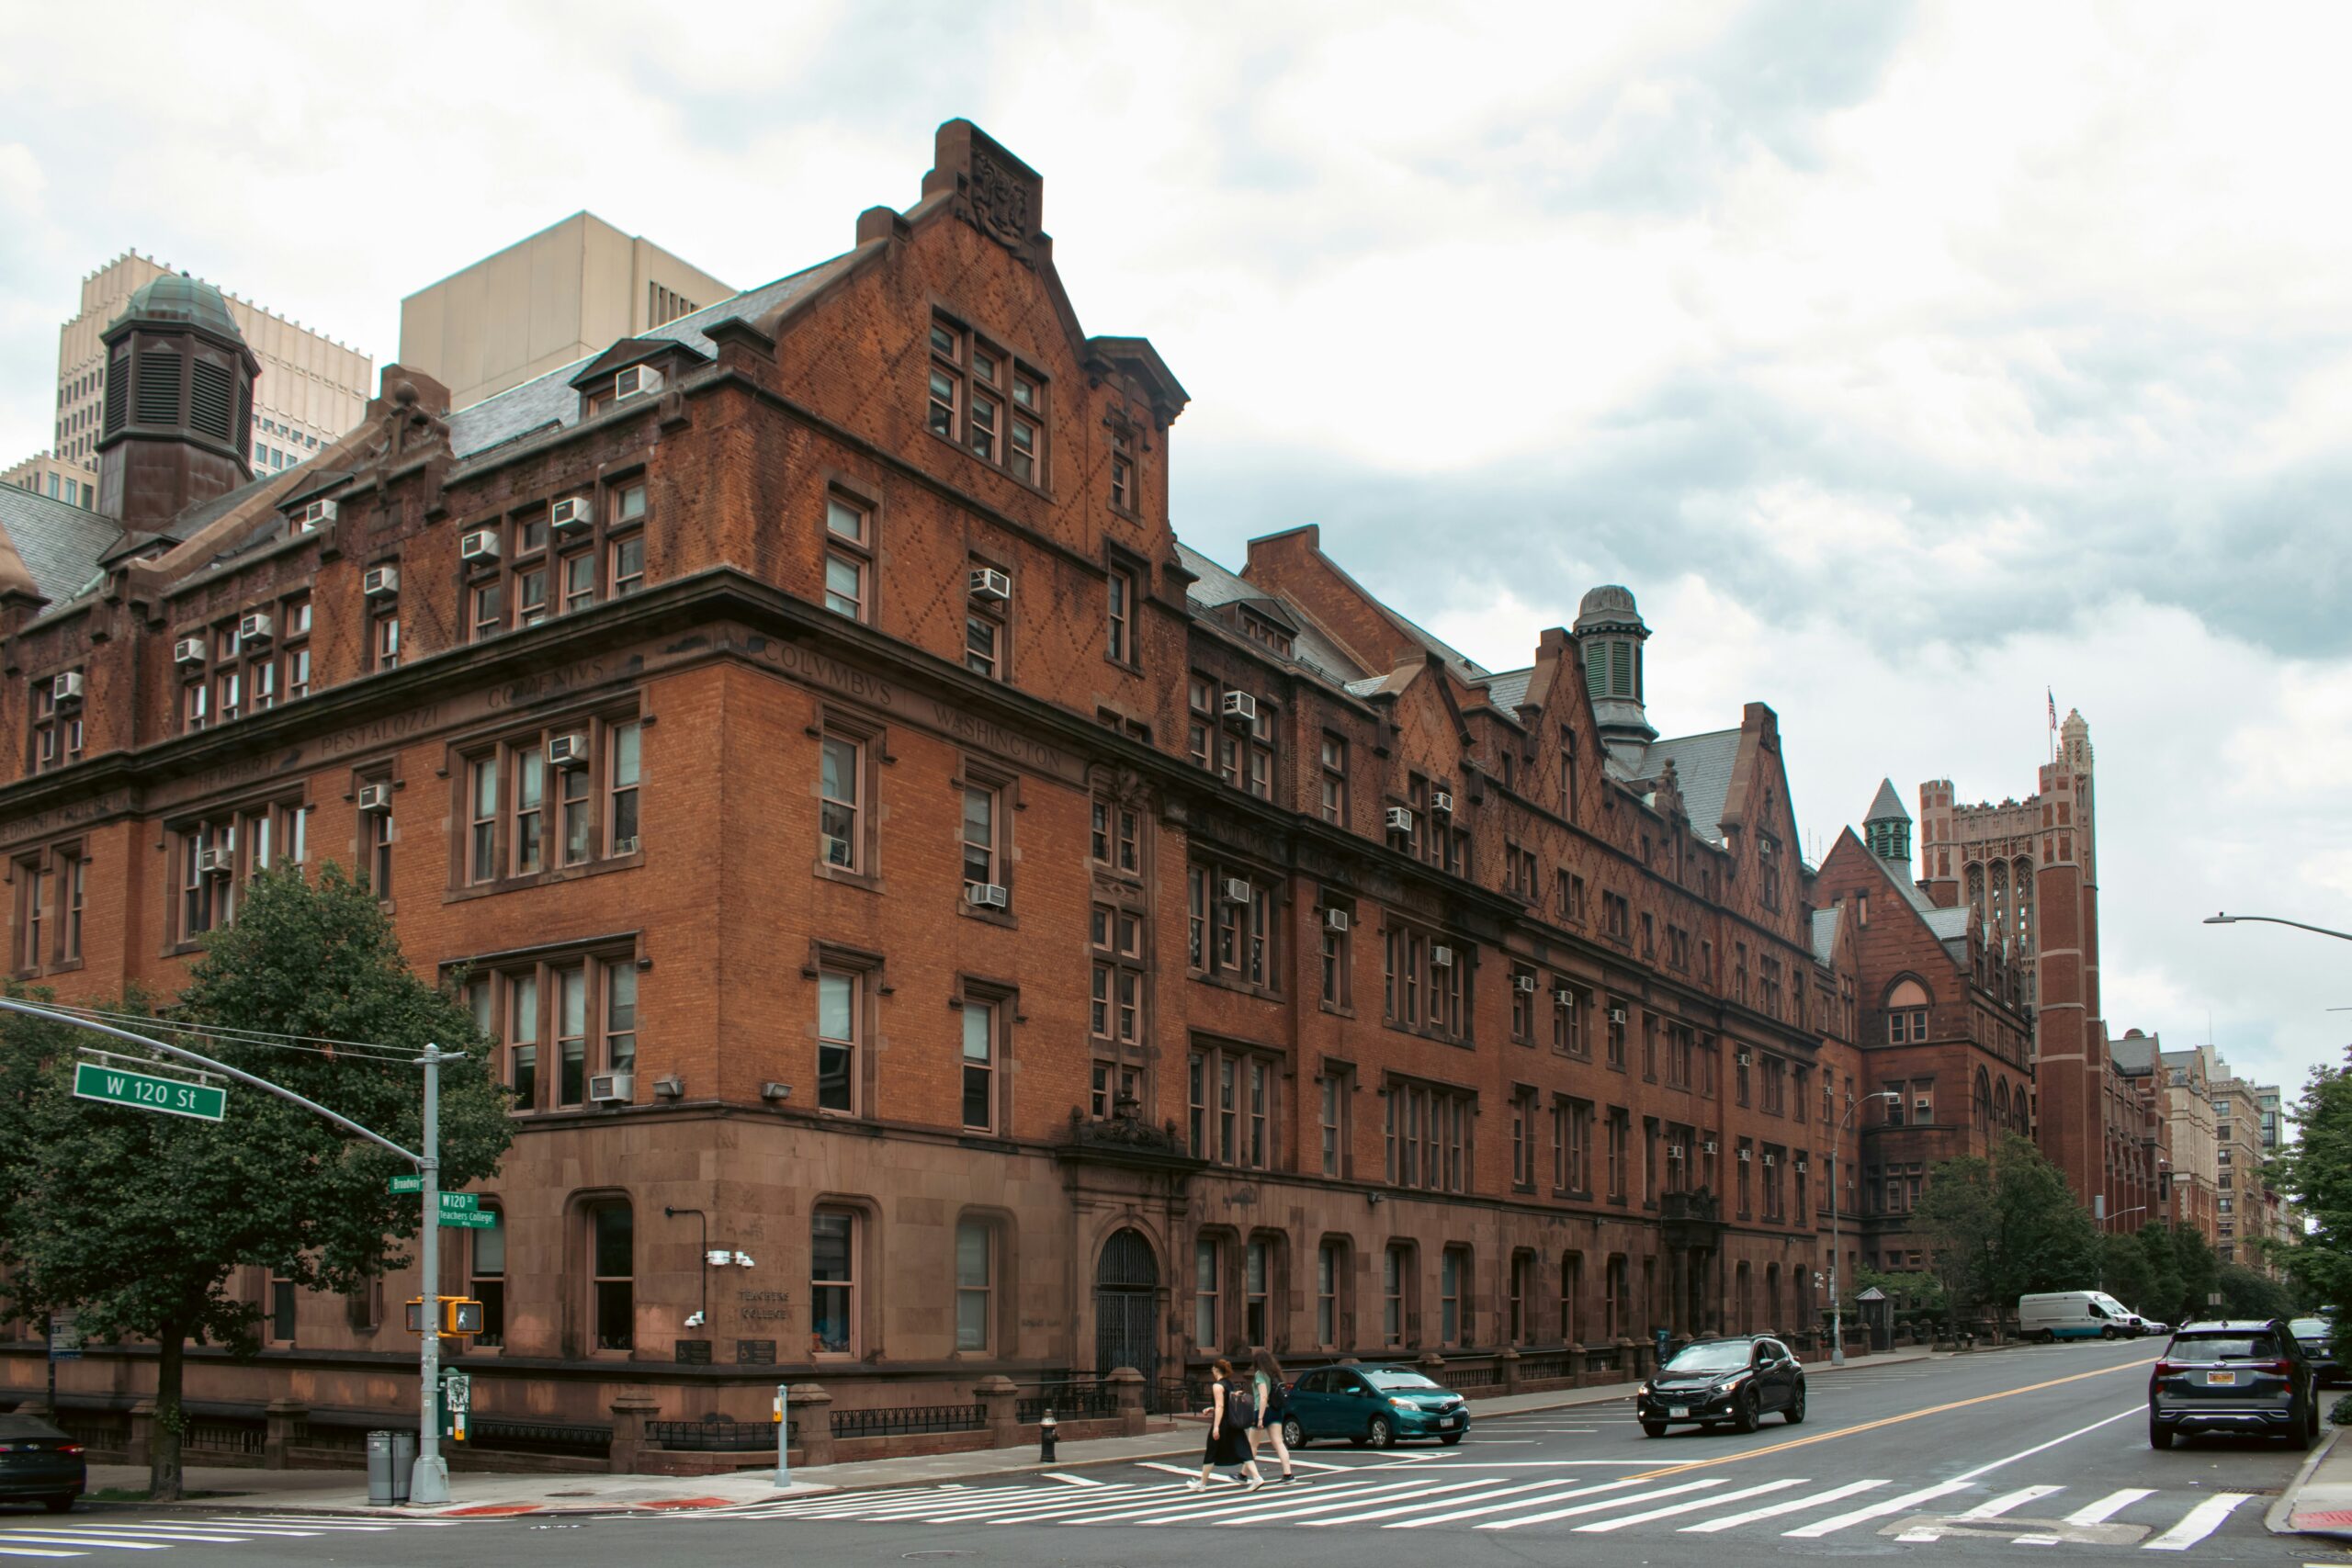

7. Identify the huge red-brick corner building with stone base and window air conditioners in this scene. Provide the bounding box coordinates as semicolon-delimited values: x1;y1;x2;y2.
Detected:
0;122;1856;1420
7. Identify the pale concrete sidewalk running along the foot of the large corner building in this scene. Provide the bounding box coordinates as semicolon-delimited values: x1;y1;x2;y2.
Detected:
89;1347;1938;1518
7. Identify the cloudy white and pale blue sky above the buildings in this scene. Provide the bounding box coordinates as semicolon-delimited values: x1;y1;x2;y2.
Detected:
0;0;2352;1104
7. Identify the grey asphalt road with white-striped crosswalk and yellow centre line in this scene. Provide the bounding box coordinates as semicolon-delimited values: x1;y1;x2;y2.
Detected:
0;1342;2352;1568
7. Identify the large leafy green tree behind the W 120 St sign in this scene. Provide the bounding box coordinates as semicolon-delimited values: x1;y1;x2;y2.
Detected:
0;863;511;1500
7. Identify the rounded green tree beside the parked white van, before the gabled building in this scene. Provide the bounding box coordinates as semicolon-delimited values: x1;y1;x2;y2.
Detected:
1912;1134;2100;1314
